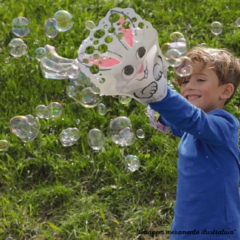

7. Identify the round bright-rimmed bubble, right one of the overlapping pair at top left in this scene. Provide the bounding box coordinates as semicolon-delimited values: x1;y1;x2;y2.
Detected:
54;10;73;32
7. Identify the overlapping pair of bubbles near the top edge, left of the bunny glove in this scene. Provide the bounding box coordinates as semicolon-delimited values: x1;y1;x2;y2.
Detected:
44;10;73;38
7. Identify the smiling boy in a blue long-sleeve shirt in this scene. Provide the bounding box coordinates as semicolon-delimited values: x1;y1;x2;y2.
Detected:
149;47;240;240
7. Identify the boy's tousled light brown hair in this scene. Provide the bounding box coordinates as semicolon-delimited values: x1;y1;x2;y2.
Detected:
177;47;240;105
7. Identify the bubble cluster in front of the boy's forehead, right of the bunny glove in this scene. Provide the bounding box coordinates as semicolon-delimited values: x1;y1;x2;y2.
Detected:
161;32;193;77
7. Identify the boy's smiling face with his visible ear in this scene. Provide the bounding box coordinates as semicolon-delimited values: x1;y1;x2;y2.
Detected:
181;63;225;113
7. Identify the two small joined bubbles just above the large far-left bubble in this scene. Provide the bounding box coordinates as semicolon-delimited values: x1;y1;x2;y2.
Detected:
35;102;62;119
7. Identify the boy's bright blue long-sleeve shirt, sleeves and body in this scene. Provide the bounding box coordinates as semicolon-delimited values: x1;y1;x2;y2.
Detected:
150;88;240;240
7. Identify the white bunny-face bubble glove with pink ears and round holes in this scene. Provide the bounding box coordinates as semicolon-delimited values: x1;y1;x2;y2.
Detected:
78;8;168;100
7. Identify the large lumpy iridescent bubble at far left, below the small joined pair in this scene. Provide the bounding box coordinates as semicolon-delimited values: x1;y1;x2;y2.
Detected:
10;115;40;142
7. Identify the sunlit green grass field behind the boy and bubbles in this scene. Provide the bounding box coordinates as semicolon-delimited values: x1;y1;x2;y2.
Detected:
0;0;240;240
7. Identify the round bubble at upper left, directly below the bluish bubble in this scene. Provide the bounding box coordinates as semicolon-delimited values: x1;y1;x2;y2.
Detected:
8;38;28;57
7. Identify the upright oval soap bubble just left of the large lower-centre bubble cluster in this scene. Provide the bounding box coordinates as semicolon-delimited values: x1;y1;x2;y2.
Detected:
87;128;105;150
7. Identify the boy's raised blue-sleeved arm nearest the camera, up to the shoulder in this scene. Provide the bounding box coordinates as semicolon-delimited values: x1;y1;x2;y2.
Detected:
150;87;238;146
